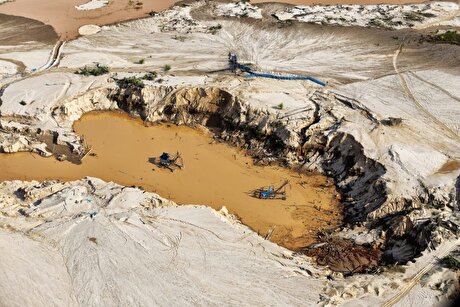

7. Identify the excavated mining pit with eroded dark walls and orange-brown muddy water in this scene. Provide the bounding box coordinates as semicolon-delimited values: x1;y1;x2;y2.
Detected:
0;87;452;273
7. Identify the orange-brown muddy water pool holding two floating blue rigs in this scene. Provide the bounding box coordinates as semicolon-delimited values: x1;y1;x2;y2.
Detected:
0;112;341;250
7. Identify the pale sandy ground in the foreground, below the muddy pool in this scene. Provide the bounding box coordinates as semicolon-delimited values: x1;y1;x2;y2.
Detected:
0;178;456;306
